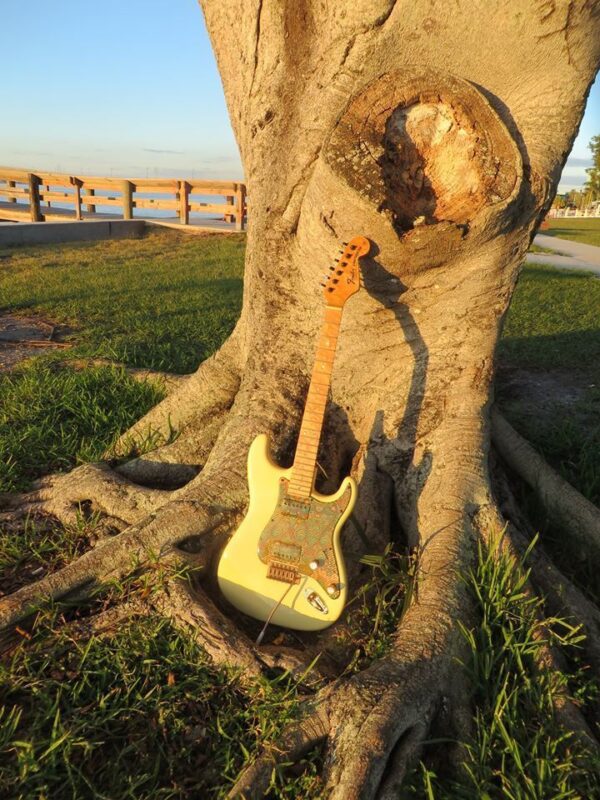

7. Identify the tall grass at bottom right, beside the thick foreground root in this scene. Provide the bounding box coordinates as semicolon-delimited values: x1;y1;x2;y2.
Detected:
410;545;600;800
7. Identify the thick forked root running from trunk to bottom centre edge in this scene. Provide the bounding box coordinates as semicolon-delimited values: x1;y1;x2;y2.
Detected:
228;496;470;800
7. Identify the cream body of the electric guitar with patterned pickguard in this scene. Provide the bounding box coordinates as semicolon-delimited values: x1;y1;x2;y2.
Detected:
218;434;356;631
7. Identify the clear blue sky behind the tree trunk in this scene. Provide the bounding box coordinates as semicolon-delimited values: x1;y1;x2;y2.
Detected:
0;0;600;192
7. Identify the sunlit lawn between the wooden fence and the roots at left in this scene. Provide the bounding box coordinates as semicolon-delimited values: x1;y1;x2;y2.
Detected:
0;229;244;373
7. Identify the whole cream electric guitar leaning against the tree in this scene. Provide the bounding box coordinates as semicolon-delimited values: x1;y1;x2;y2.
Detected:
217;236;370;638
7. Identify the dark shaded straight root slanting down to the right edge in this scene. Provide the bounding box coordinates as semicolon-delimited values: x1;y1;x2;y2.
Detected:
492;409;600;565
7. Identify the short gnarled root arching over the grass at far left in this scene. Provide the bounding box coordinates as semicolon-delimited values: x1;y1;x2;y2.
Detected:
4;463;170;530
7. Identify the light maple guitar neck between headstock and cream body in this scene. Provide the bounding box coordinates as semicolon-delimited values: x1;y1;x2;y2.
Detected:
288;306;342;498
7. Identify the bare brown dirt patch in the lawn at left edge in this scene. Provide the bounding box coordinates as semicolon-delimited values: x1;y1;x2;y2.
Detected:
0;315;71;372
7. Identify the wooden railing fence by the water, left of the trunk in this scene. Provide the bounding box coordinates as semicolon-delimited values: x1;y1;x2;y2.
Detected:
0;167;246;230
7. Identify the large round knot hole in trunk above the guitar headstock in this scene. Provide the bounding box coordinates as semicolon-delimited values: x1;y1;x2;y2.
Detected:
325;71;522;233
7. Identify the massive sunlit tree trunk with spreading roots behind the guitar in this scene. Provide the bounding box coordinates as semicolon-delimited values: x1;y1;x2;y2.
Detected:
3;0;600;799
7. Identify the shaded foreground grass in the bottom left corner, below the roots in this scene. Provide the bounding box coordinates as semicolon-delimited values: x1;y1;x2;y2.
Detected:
0;618;315;800
